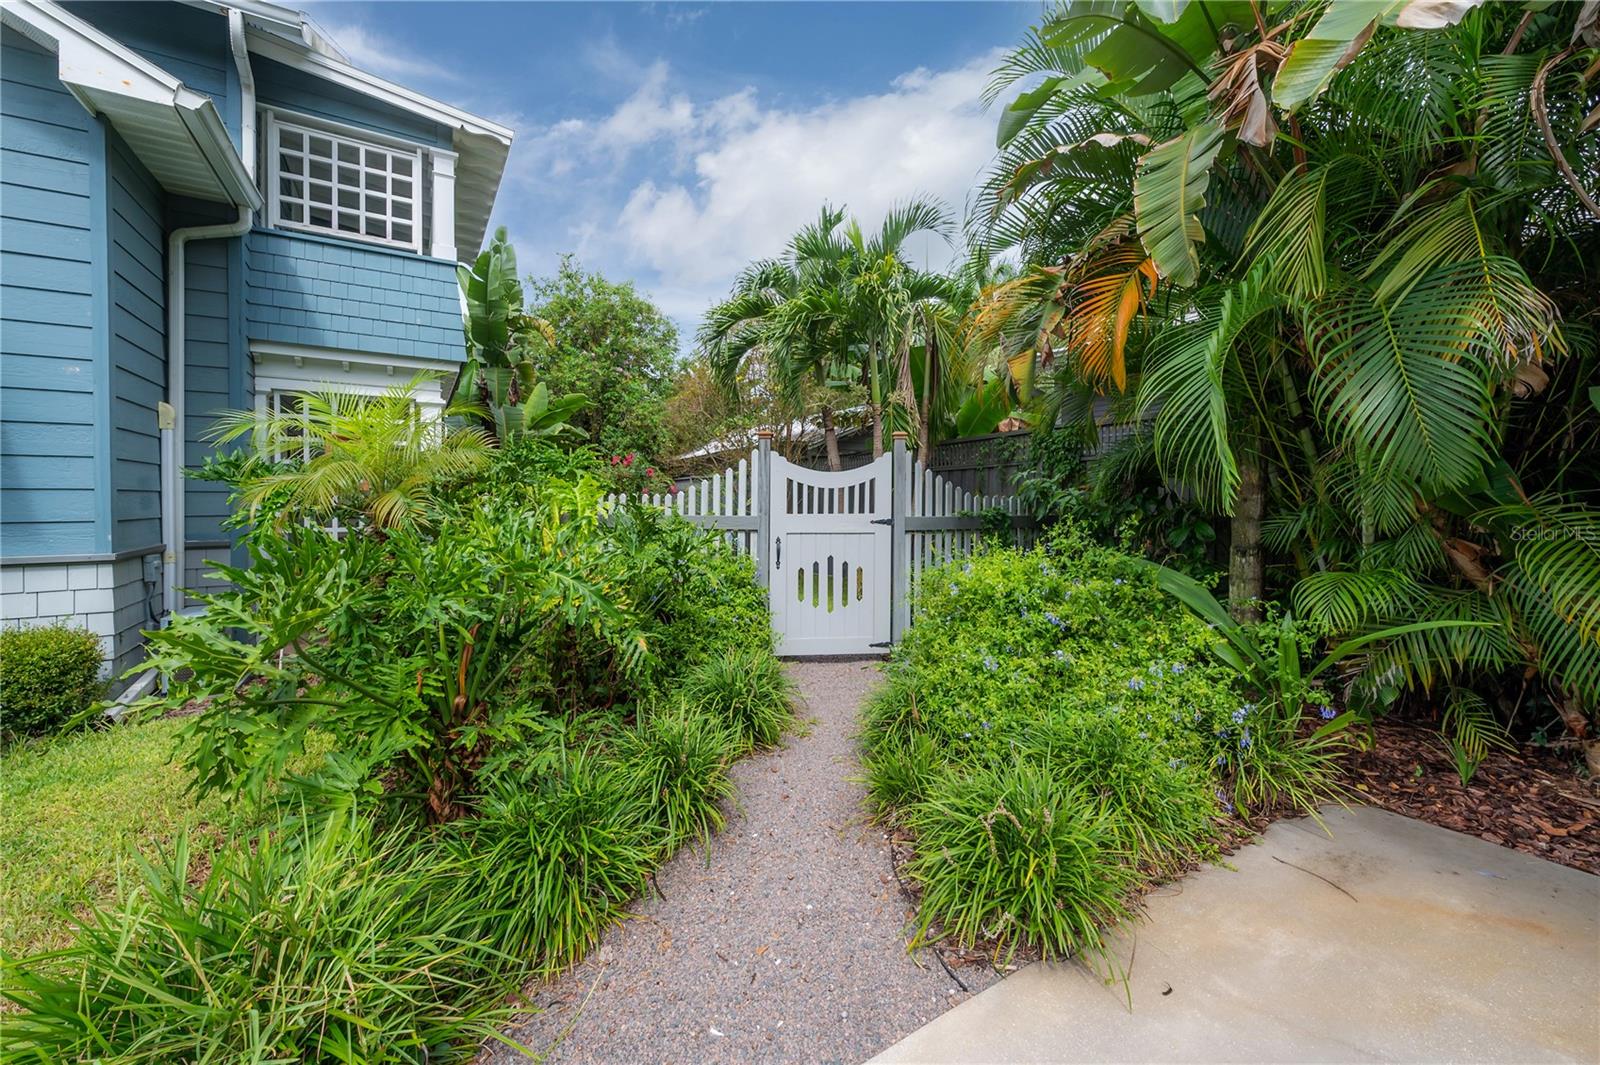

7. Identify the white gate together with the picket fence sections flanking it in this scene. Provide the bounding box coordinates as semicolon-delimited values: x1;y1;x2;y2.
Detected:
608;433;1032;656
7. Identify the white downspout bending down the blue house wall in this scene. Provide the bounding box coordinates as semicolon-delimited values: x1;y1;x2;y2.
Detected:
160;8;256;624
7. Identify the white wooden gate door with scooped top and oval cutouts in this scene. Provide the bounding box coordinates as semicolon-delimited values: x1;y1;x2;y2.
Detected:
770;454;893;656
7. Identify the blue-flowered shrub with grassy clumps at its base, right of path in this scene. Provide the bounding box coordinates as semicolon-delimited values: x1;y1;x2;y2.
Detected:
866;528;1350;955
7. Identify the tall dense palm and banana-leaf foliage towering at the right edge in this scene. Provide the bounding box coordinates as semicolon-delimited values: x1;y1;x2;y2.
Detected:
974;2;1600;729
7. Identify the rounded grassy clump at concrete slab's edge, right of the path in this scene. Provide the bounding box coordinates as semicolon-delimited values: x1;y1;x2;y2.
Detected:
907;763;1131;958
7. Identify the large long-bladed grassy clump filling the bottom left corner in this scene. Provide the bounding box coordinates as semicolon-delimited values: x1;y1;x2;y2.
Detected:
5;814;523;1063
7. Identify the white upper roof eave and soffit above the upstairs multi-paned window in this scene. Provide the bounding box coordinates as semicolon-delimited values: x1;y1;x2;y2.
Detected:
187;0;514;257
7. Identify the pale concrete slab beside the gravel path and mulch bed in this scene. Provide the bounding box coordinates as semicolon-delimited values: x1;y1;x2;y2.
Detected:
872;808;1600;1063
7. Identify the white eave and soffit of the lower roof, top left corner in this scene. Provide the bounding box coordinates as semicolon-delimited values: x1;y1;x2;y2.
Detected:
0;0;261;208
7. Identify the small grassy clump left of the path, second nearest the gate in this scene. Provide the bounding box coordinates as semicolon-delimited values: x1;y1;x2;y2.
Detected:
616;705;739;851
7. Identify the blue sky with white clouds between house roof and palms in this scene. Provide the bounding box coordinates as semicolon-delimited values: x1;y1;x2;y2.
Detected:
307;2;1040;334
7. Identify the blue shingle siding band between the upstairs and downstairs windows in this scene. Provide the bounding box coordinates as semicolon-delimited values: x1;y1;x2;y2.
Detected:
245;229;466;361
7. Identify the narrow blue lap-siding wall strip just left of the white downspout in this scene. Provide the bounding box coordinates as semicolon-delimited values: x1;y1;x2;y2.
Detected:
107;134;166;552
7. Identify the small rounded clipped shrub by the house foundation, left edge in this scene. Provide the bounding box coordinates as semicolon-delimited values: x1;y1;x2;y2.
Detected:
0;625;106;736
